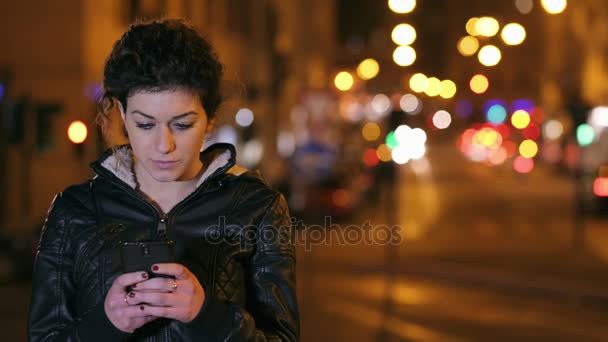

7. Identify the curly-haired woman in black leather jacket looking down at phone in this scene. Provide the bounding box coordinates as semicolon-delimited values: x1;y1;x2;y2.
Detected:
28;20;299;341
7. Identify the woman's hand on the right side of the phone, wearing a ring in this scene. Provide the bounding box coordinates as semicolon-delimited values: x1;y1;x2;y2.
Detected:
129;263;205;323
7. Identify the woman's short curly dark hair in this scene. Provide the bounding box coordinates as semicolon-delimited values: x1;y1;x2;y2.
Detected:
100;19;223;145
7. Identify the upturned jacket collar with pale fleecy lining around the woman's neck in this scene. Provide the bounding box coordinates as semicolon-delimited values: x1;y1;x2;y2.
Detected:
91;143;239;189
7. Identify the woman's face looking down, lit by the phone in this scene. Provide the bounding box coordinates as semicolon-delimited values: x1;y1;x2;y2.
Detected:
123;89;208;182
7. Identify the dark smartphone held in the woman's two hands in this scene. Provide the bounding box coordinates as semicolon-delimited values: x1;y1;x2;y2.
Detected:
120;240;175;278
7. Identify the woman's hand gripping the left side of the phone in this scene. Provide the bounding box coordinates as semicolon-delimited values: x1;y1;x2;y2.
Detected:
104;271;156;333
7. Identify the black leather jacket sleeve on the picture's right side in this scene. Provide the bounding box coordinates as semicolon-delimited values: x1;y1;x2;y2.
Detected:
176;193;299;341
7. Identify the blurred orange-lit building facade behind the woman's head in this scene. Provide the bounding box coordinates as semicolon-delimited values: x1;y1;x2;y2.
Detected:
0;0;336;231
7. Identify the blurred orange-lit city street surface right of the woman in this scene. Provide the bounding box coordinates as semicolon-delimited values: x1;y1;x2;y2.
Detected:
298;140;608;341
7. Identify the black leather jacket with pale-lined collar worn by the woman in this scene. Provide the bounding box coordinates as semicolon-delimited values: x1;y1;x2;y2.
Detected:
28;144;299;342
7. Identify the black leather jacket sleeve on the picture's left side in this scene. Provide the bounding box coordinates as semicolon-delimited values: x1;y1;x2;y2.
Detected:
28;193;126;342
